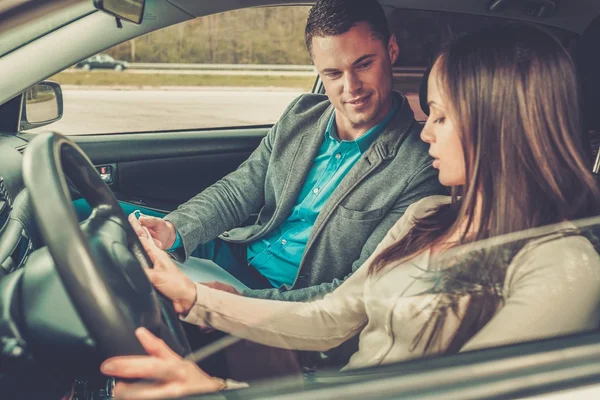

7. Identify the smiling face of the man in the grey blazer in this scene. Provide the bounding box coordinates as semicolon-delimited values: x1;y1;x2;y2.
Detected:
312;22;398;132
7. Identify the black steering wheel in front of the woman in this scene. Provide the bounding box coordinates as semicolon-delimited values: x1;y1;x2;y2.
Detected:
23;133;191;358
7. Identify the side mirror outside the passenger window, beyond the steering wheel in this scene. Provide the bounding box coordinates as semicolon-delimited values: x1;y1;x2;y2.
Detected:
20;81;63;131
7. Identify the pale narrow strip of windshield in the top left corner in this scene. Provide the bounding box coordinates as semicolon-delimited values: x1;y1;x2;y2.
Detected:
0;1;95;57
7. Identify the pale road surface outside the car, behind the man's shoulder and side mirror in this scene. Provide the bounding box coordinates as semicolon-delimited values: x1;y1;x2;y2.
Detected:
29;87;424;135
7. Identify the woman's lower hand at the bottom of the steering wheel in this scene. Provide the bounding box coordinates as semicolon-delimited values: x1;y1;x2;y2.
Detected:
100;328;222;400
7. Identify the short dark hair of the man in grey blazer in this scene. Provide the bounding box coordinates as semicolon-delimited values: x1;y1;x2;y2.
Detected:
305;0;390;57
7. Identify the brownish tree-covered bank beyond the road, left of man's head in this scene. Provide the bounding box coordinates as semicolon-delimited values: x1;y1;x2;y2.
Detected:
107;7;311;64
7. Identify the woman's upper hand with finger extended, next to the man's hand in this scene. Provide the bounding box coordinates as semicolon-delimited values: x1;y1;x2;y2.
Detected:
140;237;196;315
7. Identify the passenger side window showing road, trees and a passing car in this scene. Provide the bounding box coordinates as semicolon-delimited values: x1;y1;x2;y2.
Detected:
23;6;317;135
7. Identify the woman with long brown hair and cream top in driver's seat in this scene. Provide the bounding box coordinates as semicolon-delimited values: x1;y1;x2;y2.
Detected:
102;25;600;398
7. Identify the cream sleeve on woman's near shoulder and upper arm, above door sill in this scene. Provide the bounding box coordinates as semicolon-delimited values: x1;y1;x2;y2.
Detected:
462;236;600;351
